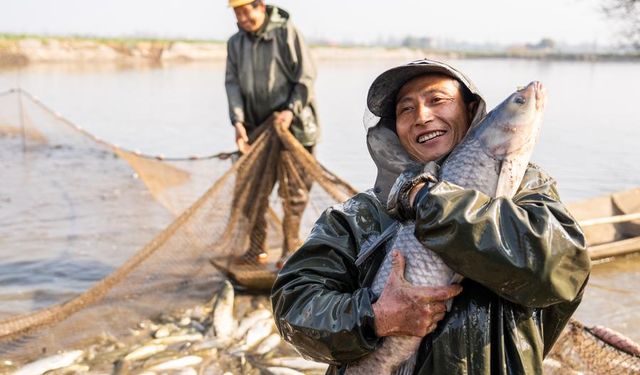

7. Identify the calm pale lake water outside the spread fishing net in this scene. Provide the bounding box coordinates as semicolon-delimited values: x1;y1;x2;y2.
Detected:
0;59;640;340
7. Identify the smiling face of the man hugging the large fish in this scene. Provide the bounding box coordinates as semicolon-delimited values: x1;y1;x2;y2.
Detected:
396;74;471;163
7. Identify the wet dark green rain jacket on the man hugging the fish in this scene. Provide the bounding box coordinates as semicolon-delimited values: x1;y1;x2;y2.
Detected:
271;64;590;375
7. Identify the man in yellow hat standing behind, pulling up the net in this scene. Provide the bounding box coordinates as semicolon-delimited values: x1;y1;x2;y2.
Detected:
225;0;318;263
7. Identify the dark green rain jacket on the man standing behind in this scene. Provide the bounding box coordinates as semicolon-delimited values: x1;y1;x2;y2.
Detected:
225;5;318;146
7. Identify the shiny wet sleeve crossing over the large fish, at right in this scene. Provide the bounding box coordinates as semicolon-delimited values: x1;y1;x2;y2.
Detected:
416;168;590;308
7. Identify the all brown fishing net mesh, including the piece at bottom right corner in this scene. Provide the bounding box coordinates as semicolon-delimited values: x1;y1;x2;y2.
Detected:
0;90;640;374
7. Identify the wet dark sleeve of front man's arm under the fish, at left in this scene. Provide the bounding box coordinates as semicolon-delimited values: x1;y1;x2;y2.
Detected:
271;193;390;364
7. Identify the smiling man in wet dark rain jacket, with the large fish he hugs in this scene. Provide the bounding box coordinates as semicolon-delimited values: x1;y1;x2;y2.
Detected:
271;60;590;375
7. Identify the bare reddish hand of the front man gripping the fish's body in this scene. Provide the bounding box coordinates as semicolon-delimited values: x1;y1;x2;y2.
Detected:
373;250;462;337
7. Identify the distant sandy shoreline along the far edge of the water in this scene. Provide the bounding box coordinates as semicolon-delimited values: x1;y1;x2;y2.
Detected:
0;34;640;66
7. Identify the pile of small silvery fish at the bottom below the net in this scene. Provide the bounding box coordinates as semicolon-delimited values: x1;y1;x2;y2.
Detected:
0;282;327;375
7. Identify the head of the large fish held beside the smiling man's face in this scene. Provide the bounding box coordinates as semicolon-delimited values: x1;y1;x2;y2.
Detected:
479;81;546;158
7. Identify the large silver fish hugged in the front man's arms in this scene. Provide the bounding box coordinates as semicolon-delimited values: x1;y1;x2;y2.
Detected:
346;82;546;375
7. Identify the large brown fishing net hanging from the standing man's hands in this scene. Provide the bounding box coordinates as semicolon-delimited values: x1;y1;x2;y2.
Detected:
0;91;355;359
